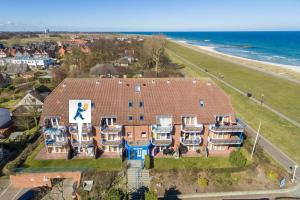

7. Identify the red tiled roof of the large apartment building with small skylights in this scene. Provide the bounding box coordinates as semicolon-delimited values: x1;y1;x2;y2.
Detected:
41;78;234;125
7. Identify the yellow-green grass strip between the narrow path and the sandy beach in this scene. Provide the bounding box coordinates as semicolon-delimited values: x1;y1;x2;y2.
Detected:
167;42;300;122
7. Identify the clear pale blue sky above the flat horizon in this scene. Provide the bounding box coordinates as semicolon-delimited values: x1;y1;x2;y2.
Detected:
0;0;300;31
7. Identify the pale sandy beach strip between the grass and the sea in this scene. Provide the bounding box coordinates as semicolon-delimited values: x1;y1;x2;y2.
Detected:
172;40;300;83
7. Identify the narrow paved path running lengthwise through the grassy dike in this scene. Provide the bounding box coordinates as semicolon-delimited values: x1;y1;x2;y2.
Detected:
167;49;300;128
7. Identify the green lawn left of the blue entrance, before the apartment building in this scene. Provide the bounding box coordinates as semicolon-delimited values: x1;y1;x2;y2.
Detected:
23;143;122;171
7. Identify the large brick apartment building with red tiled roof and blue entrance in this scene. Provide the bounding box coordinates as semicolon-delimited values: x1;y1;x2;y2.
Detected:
40;78;244;159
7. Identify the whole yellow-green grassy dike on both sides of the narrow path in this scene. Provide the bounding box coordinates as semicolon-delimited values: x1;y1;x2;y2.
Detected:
167;42;300;163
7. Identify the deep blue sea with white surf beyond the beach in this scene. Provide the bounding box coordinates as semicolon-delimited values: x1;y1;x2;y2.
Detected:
121;31;300;68
